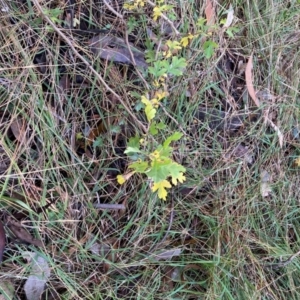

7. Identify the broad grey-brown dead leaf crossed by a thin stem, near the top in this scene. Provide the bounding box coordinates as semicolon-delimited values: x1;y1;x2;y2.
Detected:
89;35;148;68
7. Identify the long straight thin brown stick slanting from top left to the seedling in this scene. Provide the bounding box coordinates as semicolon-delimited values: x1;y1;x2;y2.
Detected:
33;0;147;132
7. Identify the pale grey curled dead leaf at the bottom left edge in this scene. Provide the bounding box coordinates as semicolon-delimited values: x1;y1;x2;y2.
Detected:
22;251;50;300
